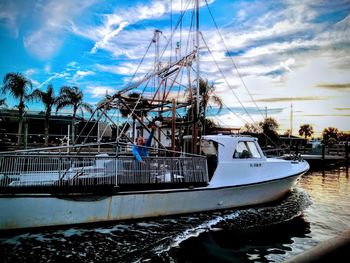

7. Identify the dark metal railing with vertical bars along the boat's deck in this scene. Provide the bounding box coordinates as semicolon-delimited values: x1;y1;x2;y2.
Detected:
0;154;208;193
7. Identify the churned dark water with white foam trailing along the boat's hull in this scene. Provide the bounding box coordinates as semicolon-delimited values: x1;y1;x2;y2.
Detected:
0;188;311;262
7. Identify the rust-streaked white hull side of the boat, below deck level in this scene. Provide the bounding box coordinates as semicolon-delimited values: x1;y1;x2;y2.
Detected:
0;174;300;230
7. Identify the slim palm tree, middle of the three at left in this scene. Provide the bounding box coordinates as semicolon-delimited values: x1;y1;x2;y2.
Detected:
30;85;57;146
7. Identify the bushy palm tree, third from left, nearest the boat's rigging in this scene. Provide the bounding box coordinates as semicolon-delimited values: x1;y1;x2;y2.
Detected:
56;86;93;143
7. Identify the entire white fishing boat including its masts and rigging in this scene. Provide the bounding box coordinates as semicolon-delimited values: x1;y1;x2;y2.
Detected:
0;1;309;230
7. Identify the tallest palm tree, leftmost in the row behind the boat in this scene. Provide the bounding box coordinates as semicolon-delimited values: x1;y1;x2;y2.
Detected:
1;73;32;146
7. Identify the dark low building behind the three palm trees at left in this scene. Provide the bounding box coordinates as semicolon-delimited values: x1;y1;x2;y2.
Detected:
0;109;113;151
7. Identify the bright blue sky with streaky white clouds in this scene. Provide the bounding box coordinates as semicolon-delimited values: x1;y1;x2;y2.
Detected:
0;0;350;136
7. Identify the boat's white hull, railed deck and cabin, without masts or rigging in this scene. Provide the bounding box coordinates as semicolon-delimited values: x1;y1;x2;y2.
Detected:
0;135;309;230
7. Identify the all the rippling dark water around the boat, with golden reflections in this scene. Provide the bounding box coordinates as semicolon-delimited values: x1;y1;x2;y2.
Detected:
0;168;350;262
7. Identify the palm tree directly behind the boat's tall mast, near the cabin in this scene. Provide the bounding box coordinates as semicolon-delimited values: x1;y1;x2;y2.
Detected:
186;78;223;134
